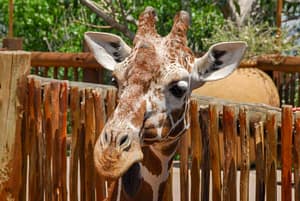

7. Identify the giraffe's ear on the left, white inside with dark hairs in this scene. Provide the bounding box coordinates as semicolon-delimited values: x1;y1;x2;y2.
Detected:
84;32;131;71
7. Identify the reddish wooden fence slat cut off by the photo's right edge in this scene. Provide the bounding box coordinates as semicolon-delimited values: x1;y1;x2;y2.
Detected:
294;112;300;201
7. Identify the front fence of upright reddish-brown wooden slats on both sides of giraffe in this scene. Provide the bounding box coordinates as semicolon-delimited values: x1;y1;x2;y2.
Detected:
0;52;300;201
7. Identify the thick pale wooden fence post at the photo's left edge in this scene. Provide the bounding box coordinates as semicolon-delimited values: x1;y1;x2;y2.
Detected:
0;51;30;200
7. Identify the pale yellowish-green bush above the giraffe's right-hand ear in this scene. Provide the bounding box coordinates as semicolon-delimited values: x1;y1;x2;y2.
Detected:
205;21;299;58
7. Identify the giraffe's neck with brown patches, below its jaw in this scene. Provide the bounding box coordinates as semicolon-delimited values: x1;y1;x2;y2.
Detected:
108;139;178;201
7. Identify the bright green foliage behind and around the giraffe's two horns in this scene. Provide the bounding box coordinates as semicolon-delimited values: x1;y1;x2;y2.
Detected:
98;0;224;51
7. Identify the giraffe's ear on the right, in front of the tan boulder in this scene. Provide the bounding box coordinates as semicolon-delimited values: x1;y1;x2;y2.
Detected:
192;41;247;88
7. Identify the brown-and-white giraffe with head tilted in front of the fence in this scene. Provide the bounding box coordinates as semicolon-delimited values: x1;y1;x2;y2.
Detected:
84;7;247;201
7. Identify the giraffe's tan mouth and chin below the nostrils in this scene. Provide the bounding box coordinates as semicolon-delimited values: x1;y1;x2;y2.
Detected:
94;141;143;179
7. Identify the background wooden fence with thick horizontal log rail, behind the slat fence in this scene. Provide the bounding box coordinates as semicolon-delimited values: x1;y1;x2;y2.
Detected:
31;52;300;107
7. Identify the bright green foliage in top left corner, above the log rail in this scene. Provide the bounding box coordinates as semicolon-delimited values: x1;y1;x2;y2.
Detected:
0;0;102;52
